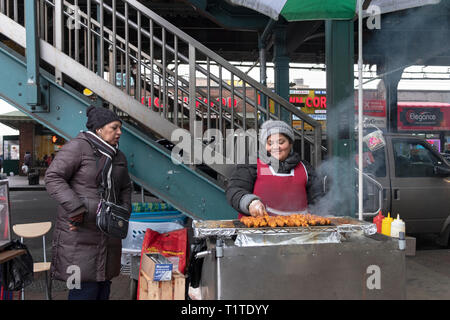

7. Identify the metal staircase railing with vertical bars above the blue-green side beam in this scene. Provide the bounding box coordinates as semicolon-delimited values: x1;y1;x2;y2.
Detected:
0;0;323;172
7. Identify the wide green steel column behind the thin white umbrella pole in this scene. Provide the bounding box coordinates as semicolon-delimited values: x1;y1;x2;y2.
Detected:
325;20;356;216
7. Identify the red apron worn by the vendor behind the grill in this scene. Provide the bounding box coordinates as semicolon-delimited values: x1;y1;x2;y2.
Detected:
239;159;308;218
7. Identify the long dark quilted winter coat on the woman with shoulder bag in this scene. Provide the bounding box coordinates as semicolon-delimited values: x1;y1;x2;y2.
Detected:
45;132;131;282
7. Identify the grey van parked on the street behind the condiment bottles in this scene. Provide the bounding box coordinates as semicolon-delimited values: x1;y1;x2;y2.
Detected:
364;134;450;245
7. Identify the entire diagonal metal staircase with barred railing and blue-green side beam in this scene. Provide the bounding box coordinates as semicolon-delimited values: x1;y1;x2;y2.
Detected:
0;0;323;219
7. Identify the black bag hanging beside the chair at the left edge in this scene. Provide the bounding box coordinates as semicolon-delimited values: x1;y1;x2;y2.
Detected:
0;240;33;291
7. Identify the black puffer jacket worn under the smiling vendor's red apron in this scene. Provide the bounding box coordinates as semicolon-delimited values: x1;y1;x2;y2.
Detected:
226;153;323;214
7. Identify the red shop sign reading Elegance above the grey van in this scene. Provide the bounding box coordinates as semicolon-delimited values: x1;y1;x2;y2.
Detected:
397;102;450;131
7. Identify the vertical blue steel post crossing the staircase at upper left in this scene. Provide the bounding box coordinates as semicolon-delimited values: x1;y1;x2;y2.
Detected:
25;1;41;110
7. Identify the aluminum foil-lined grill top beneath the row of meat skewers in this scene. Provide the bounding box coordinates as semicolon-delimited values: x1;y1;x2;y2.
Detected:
192;217;377;238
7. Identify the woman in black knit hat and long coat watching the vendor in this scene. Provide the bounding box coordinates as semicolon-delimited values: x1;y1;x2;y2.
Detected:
45;106;131;300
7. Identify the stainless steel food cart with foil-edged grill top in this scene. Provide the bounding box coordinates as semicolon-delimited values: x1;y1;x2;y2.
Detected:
193;217;406;300
